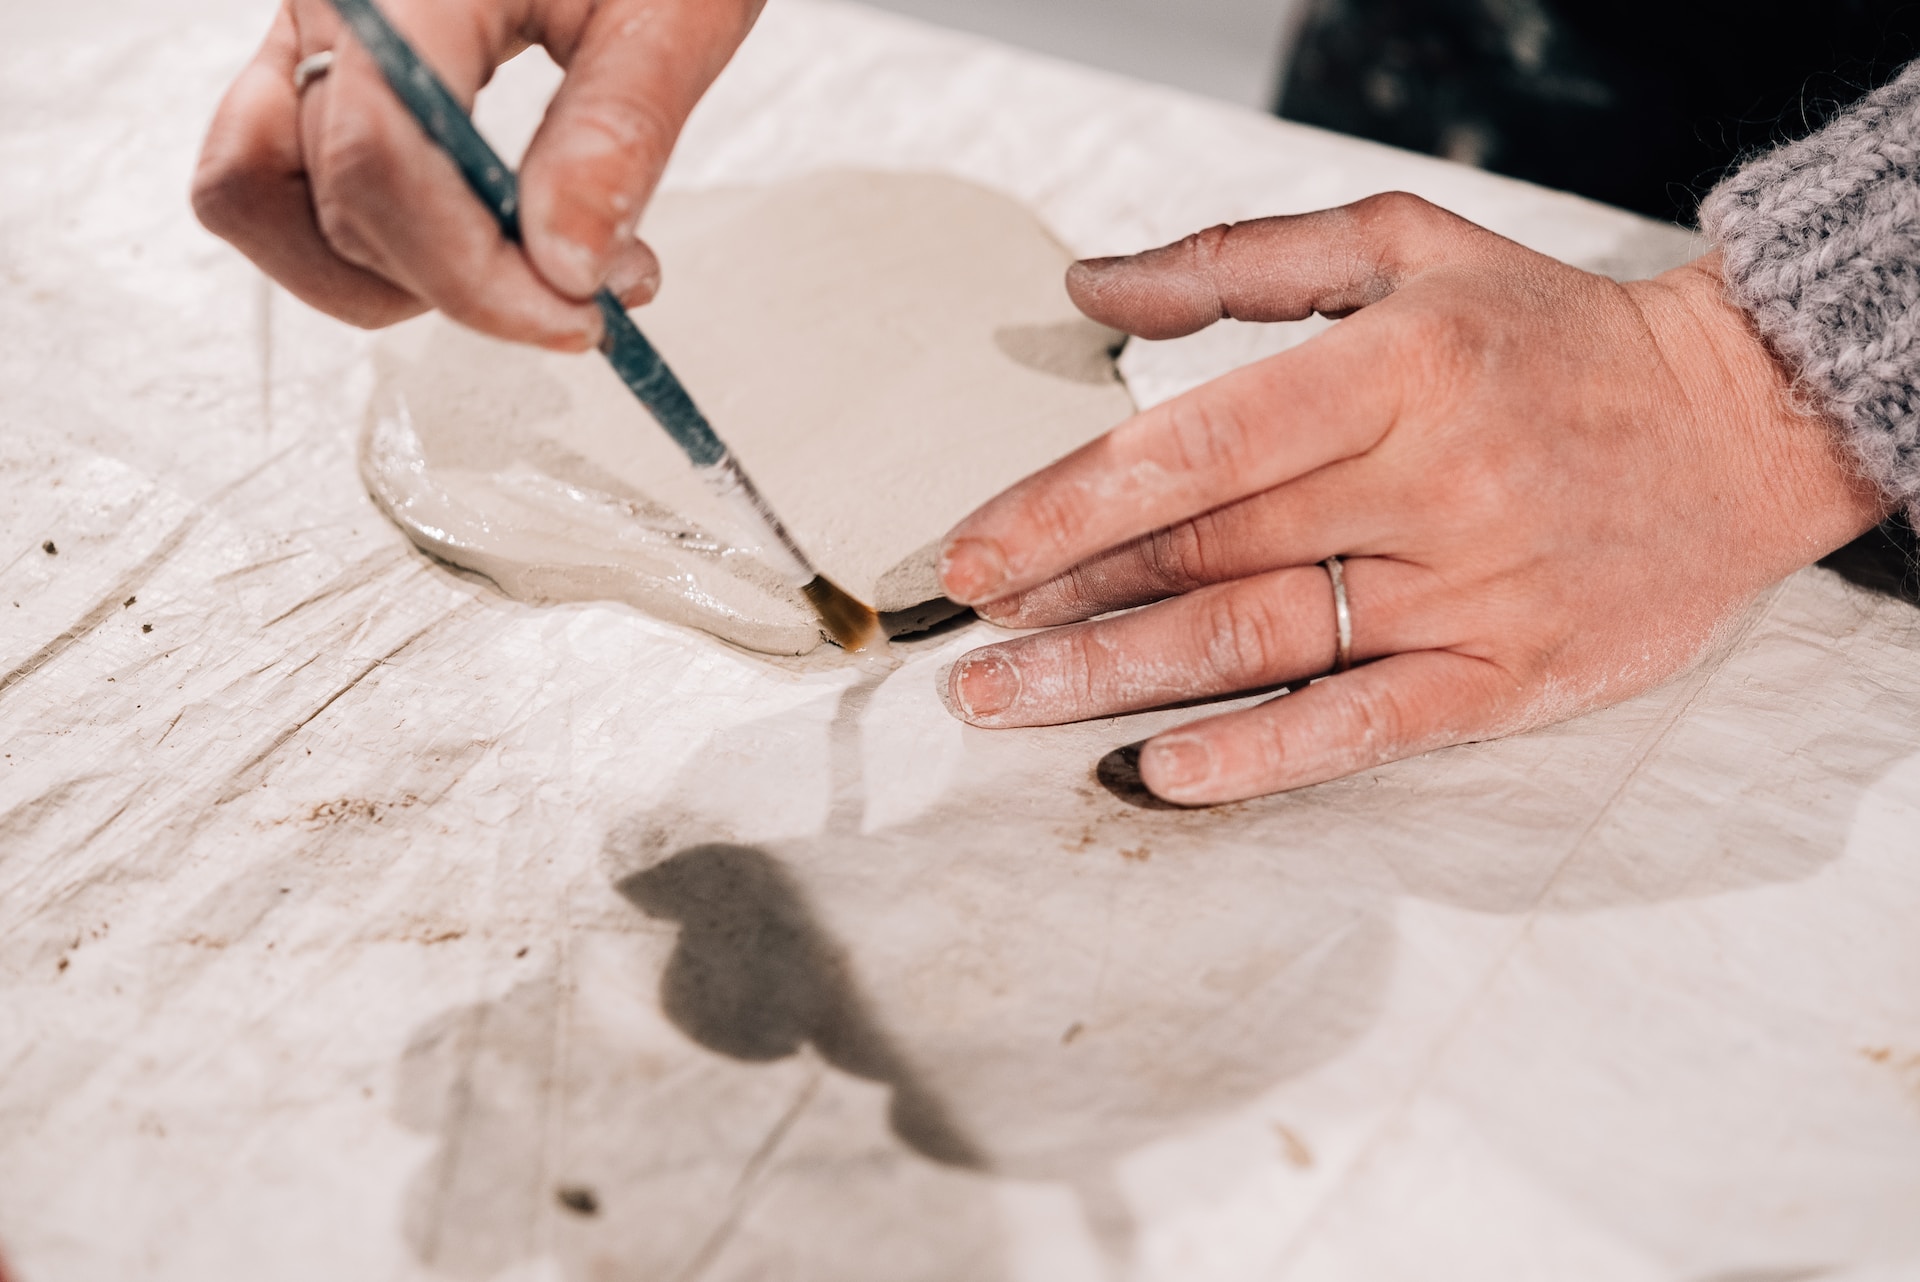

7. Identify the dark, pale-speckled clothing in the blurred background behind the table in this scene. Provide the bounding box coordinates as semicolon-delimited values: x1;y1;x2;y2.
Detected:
1277;0;1920;223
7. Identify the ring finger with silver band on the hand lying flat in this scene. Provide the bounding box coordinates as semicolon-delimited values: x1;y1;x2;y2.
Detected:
948;558;1434;727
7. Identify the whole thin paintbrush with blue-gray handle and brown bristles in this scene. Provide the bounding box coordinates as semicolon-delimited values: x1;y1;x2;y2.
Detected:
320;0;881;651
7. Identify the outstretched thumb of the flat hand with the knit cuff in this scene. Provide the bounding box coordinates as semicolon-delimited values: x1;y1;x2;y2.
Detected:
1068;192;1490;340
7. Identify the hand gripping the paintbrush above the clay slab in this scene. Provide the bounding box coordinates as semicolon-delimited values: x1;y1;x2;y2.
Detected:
194;0;764;351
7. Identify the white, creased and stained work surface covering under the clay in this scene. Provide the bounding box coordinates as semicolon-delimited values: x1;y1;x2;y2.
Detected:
0;0;1920;1282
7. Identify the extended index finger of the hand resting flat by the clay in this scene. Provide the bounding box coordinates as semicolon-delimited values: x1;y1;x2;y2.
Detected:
941;309;1400;605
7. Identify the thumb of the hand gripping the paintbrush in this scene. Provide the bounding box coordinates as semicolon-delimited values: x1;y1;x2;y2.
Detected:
520;0;764;303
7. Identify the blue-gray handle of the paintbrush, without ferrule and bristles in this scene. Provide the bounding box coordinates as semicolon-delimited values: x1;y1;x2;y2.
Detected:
332;0;726;468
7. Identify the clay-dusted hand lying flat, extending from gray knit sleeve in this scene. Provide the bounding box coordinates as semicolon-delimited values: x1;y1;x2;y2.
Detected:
941;194;1887;804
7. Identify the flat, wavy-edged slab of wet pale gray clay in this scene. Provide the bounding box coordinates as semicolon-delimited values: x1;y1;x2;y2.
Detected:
361;173;1133;654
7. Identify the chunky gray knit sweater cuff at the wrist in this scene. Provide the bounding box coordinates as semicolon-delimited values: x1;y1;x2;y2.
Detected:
1699;61;1920;520
